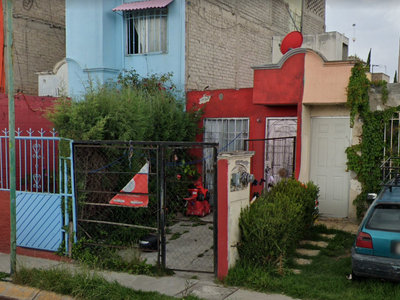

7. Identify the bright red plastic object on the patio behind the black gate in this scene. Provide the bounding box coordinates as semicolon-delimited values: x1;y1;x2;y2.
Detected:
183;182;211;217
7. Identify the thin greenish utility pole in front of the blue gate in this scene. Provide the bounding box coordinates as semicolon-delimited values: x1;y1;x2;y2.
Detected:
6;0;17;276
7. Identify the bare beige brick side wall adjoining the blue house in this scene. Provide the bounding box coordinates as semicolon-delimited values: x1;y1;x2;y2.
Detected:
186;0;325;90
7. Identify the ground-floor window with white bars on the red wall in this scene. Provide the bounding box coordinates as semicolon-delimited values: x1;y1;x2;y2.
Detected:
204;118;249;152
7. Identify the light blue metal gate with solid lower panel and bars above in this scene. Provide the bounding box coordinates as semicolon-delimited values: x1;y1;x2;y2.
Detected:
0;128;76;251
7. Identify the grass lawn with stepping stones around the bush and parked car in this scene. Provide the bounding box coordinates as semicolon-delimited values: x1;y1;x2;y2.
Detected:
225;225;400;300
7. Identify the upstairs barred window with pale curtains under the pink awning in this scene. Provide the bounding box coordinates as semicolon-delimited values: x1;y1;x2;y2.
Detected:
125;8;168;54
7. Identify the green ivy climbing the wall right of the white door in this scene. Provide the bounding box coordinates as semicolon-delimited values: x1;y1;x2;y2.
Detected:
346;62;400;218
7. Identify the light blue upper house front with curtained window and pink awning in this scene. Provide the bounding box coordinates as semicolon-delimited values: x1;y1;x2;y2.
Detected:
66;0;185;95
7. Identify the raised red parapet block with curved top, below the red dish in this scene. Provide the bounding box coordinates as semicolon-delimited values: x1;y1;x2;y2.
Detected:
253;53;305;105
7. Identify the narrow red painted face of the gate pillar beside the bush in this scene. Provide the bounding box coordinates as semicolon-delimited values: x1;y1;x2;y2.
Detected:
217;159;229;280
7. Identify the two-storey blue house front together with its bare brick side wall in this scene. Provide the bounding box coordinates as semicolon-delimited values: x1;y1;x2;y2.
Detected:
47;0;325;95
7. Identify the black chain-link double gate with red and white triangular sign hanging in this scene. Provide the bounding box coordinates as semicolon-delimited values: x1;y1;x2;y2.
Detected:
73;142;217;272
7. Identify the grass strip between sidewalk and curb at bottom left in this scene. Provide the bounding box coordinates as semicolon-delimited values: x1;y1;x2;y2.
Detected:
13;268;205;300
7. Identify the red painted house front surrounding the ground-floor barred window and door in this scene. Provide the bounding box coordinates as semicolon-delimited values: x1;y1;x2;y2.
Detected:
186;53;305;195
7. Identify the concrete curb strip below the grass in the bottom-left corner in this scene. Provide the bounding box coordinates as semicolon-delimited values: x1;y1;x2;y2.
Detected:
0;282;75;300
